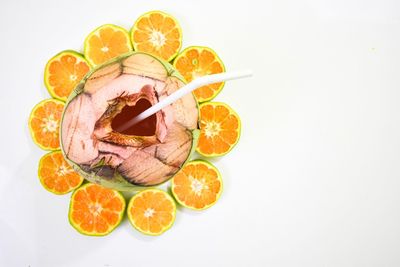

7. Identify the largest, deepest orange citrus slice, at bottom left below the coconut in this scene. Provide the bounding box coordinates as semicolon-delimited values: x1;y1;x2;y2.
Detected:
68;183;125;236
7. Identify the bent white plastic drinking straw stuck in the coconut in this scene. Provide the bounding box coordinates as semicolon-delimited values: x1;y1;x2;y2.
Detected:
118;70;253;132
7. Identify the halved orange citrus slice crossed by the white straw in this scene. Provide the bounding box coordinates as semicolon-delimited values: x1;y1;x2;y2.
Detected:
174;46;225;102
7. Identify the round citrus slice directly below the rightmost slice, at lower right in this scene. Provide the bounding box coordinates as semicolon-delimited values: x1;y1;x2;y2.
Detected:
172;160;222;210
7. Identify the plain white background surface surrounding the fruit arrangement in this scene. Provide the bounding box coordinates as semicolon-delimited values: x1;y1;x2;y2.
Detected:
0;0;400;267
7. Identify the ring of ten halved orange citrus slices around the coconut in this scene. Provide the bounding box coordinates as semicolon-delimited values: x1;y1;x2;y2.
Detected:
28;11;241;236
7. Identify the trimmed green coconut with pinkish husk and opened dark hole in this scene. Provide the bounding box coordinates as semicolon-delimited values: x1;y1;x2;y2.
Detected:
60;52;199;191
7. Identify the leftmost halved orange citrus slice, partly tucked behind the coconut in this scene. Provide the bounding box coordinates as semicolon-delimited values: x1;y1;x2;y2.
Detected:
29;99;64;150
